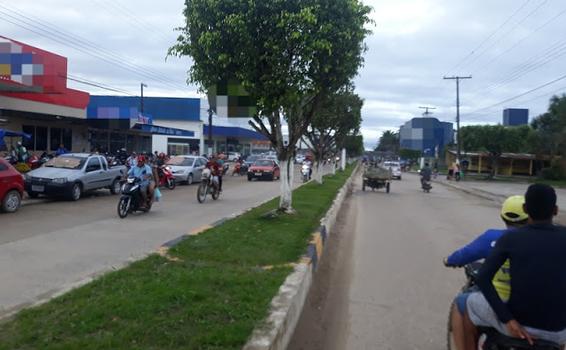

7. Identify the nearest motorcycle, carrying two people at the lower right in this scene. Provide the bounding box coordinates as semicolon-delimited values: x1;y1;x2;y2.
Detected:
446;262;562;350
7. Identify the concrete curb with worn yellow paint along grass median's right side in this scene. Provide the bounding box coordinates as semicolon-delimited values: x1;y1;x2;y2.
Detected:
243;164;361;350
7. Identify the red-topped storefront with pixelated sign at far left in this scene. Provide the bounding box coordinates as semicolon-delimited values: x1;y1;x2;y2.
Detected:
0;36;89;152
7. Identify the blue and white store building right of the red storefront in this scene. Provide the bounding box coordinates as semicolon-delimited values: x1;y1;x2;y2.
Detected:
87;96;202;154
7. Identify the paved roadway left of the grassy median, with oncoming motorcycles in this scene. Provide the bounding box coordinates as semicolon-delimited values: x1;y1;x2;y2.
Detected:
0;168;310;318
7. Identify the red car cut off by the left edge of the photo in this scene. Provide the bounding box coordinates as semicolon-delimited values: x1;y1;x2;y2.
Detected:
0;158;24;213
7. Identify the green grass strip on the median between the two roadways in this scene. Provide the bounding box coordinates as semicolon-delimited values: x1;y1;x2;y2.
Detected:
0;167;353;349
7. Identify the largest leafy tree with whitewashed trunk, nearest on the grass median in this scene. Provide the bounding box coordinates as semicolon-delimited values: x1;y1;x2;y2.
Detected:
169;0;370;212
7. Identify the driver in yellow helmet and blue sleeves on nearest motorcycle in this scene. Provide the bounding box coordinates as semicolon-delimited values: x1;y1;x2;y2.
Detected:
444;196;528;350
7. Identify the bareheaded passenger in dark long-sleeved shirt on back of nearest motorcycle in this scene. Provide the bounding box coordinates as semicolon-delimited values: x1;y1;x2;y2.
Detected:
454;184;566;350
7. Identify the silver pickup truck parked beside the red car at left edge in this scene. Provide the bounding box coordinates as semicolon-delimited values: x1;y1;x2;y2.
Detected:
25;153;127;201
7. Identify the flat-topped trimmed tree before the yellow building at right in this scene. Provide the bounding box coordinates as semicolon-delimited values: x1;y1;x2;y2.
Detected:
460;125;532;177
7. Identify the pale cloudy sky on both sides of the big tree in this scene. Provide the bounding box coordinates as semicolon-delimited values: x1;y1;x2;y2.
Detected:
0;0;566;147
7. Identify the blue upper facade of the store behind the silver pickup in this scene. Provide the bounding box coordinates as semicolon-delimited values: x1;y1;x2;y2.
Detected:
87;95;200;121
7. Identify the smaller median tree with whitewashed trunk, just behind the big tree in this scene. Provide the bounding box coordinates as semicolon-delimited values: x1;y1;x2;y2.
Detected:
305;87;363;183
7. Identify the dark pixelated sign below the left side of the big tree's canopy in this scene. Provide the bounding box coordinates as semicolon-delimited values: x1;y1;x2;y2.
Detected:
208;80;257;118
